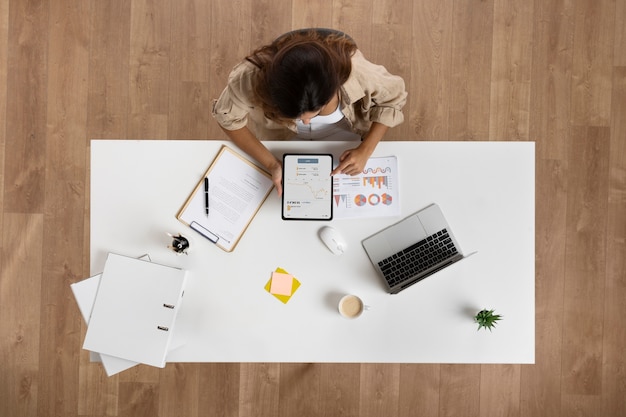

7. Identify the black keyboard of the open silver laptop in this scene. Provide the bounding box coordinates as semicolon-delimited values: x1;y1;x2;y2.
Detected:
378;229;457;287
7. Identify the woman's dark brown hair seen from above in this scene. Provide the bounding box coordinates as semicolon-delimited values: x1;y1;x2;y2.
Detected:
246;30;356;121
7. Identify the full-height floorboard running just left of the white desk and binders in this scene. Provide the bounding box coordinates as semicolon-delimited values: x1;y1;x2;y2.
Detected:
38;1;90;416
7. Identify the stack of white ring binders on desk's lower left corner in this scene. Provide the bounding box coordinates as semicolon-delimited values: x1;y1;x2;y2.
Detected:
72;253;187;376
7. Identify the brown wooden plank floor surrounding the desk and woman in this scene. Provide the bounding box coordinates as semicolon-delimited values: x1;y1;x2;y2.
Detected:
0;0;626;417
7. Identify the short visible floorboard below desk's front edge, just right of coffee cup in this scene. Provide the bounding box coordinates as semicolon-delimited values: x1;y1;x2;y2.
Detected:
359;363;400;417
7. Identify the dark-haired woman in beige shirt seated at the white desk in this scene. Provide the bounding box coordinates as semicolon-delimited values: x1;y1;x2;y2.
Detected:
212;29;406;195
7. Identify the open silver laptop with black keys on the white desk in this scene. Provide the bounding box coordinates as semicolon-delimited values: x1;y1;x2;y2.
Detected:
362;204;463;294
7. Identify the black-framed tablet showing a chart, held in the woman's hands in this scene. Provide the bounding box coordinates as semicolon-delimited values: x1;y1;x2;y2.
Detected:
282;154;333;220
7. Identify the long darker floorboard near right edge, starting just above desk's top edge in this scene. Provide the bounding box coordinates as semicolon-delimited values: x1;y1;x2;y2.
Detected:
561;127;610;415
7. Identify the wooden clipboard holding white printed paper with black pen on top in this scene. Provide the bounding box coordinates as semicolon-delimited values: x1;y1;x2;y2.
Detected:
176;145;274;252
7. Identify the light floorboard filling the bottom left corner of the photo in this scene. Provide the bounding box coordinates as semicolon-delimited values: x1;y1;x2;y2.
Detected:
0;213;46;417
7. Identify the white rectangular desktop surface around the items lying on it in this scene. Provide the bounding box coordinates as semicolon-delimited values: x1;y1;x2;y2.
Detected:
91;140;535;363
